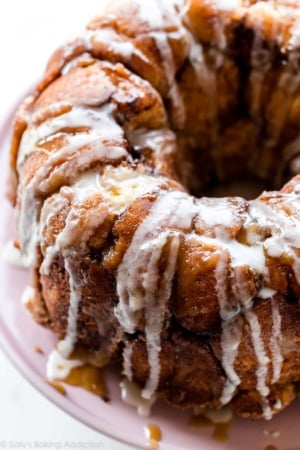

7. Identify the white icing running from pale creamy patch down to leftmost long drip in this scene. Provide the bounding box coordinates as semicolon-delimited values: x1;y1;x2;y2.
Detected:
40;166;169;358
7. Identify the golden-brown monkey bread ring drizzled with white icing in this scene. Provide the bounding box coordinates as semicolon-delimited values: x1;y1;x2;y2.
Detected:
10;0;300;419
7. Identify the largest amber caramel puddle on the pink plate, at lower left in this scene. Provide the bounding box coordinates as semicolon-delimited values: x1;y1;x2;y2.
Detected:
63;365;108;401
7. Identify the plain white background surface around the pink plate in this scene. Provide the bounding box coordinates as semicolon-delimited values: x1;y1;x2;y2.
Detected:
0;0;131;450
